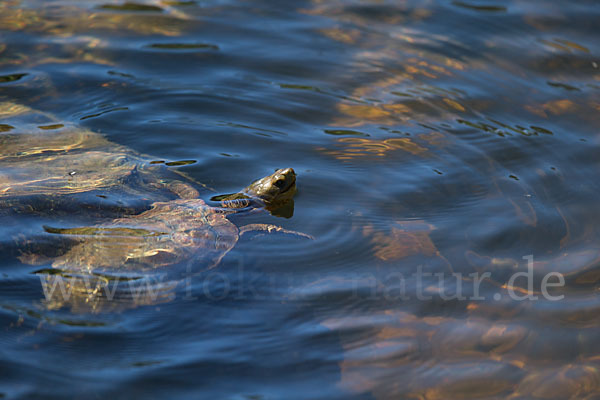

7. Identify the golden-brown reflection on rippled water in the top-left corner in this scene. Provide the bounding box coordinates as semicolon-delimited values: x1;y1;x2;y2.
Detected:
0;0;198;66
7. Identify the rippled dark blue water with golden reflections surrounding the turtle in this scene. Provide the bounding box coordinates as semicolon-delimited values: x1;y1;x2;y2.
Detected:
0;0;600;400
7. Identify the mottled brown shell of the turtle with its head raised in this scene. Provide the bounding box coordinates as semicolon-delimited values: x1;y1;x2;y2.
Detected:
46;199;239;273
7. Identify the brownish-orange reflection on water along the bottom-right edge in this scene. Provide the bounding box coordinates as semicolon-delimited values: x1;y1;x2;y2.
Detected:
323;296;600;400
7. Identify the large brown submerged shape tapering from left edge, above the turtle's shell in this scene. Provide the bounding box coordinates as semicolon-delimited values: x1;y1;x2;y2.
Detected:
0;102;203;216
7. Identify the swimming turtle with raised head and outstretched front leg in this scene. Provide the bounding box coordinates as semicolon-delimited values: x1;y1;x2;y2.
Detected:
20;168;313;312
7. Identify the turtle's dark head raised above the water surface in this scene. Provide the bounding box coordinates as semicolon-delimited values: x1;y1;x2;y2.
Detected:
242;168;296;206
